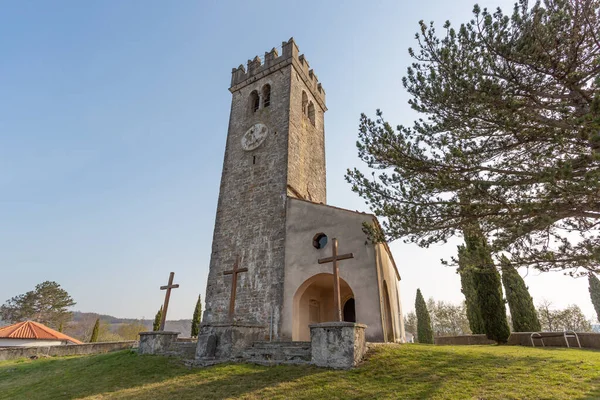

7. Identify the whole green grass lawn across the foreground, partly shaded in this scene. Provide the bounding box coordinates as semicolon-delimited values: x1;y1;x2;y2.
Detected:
0;344;600;400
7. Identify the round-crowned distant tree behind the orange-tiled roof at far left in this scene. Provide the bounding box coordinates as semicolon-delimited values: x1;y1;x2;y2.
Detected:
0;281;76;329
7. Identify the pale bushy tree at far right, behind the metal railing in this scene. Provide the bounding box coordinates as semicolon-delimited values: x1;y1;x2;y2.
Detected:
538;300;592;332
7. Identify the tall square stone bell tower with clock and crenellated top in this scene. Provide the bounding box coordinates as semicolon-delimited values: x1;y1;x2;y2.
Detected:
197;39;327;359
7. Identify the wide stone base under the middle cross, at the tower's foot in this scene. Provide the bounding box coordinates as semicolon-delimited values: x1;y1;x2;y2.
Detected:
196;322;268;363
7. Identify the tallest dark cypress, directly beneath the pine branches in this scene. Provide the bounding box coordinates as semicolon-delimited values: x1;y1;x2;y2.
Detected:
464;226;510;343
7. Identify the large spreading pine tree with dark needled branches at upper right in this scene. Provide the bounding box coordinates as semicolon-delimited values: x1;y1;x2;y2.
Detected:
346;0;600;276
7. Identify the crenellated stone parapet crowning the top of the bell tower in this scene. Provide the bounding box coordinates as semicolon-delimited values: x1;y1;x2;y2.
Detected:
229;38;327;110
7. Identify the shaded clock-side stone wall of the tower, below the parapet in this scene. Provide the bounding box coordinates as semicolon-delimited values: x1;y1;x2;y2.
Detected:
203;65;291;332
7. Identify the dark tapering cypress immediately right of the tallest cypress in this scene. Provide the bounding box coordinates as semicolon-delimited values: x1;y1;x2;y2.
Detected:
501;257;542;332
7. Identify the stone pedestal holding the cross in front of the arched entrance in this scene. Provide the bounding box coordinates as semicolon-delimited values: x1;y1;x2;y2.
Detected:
309;322;367;369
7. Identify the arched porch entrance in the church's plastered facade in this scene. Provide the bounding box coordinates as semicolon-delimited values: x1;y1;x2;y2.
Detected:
292;274;356;341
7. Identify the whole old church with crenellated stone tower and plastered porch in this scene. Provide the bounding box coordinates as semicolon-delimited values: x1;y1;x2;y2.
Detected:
196;39;405;359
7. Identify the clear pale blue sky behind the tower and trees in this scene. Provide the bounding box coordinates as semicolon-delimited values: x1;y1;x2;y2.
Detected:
0;0;593;319
